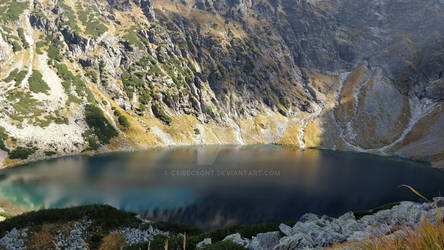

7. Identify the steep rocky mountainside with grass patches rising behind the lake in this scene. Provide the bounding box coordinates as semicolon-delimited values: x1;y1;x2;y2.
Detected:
0;0;444;167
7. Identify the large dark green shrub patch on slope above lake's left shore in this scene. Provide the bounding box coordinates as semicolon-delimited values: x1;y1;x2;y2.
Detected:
85;104;118;144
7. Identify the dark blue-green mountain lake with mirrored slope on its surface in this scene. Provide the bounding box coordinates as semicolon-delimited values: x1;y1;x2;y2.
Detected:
0;145;444;229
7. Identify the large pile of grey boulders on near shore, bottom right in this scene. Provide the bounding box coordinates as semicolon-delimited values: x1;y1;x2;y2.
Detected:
200;198;444;250
